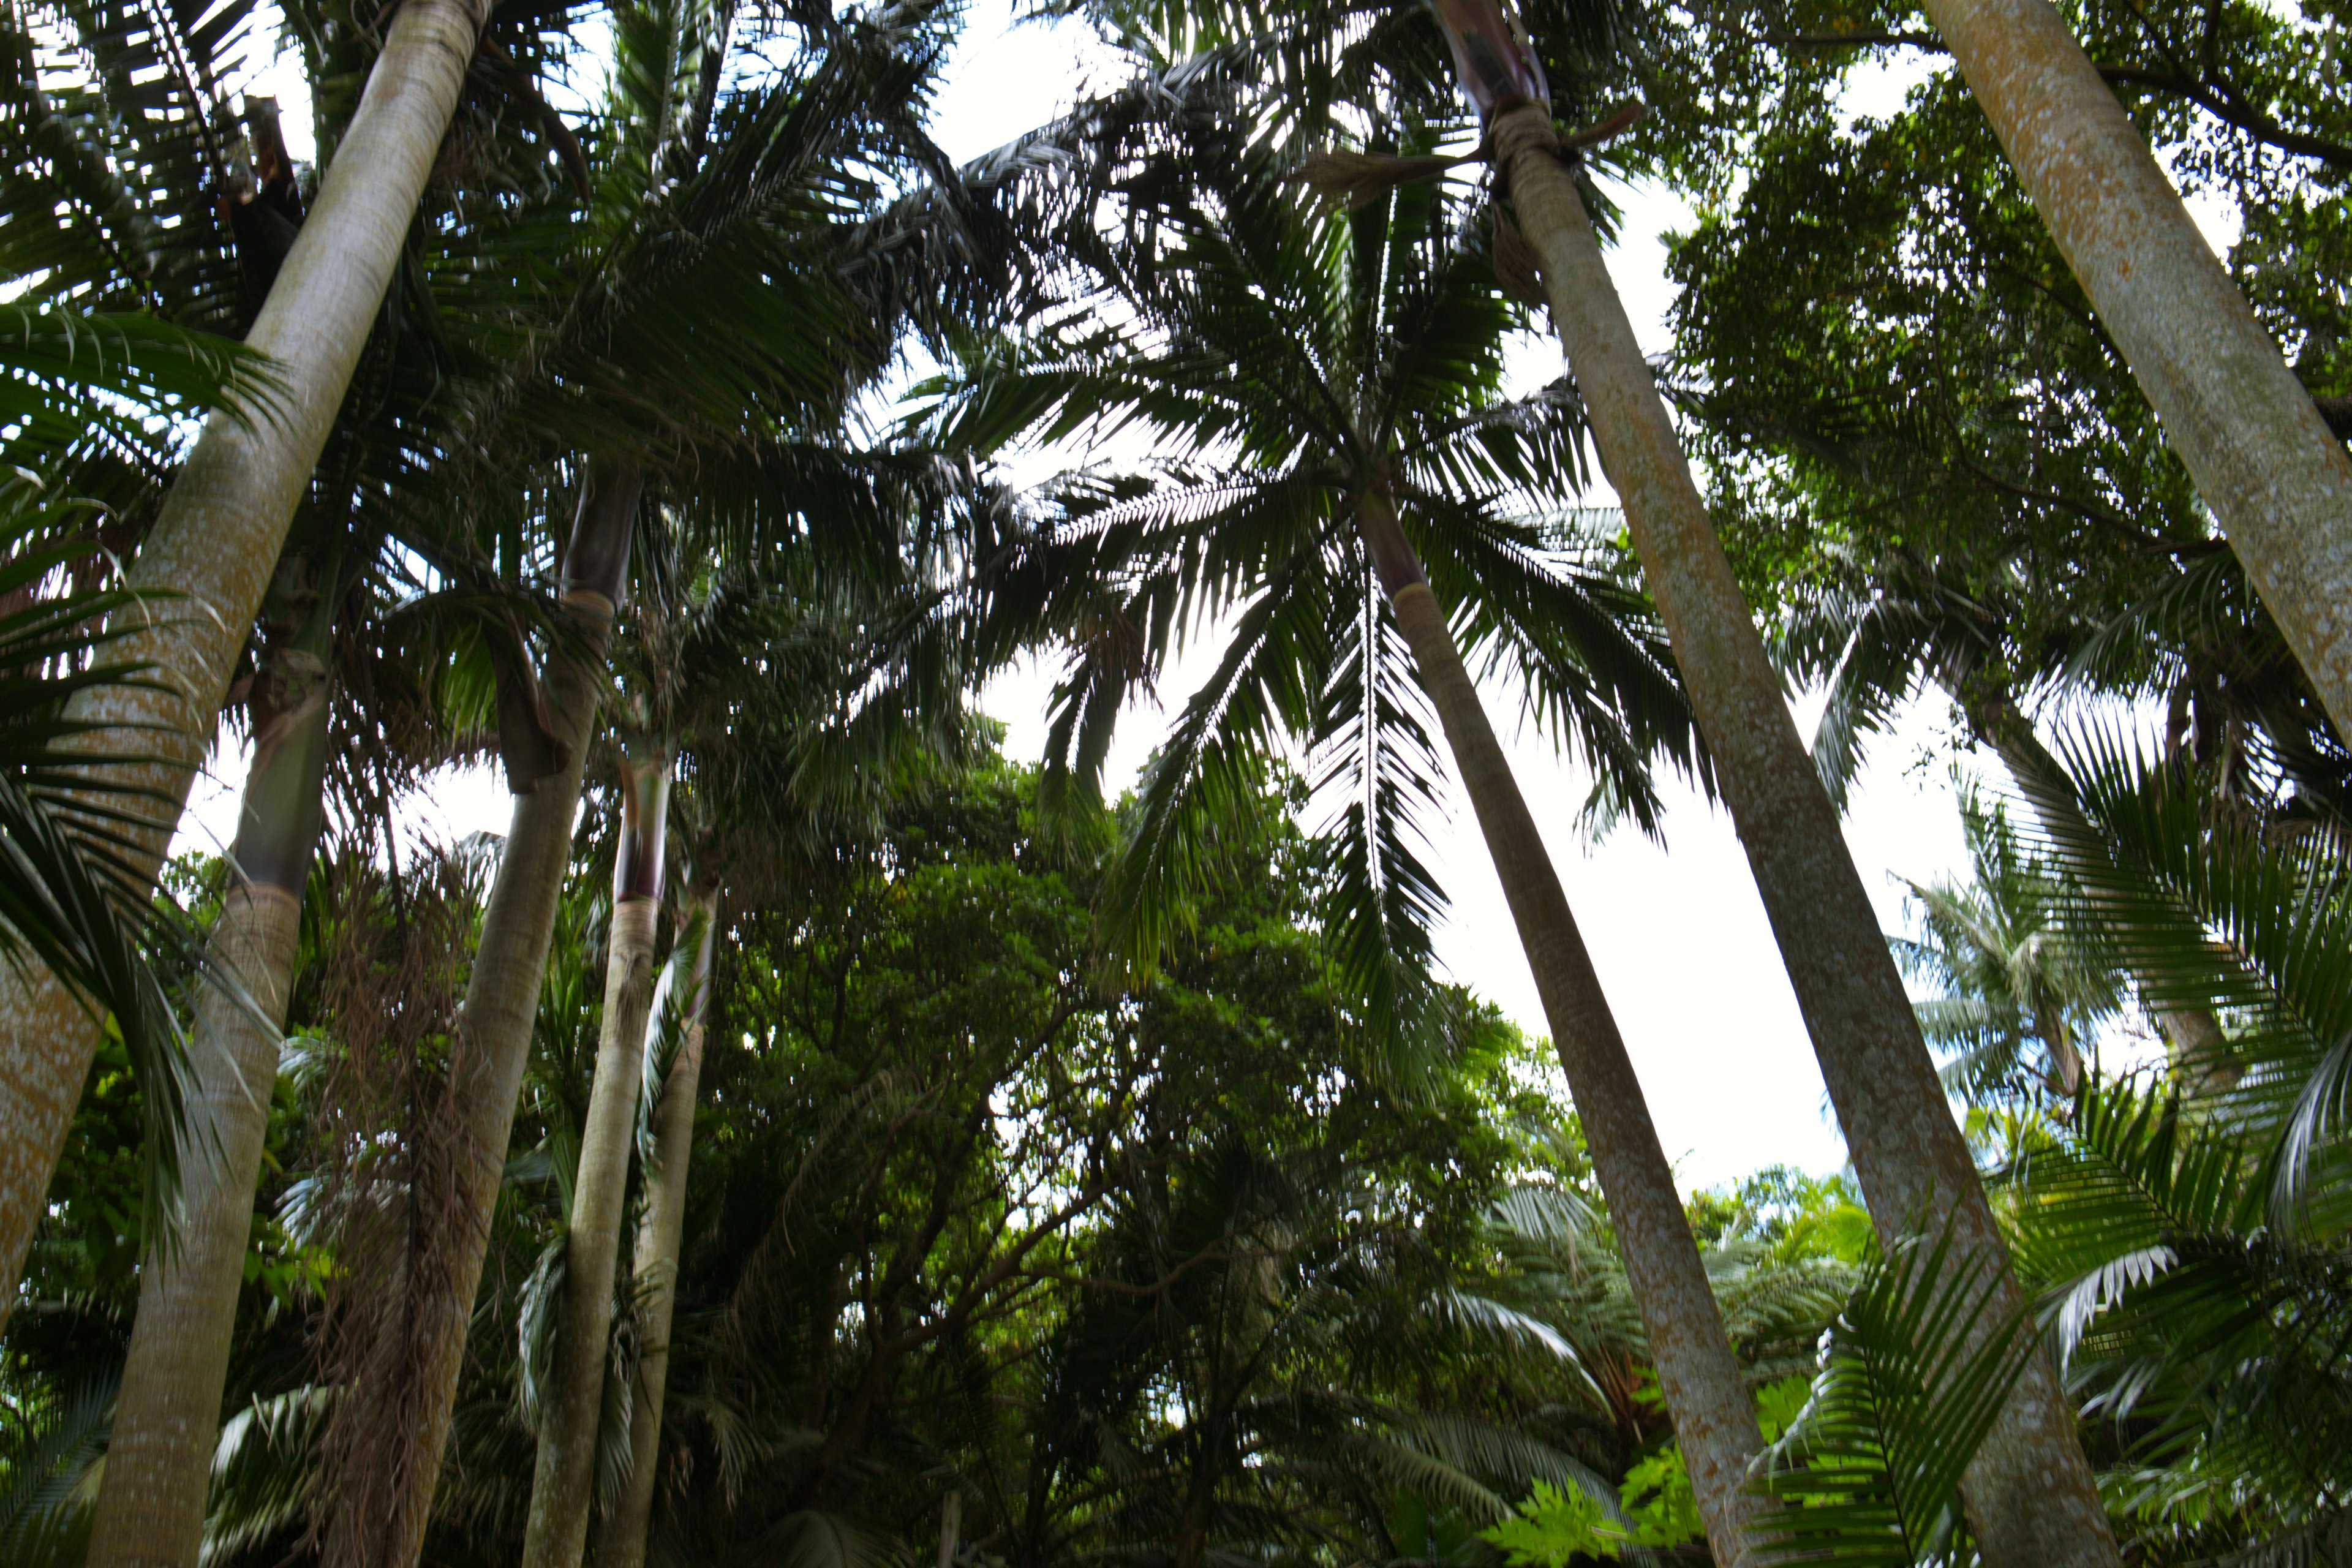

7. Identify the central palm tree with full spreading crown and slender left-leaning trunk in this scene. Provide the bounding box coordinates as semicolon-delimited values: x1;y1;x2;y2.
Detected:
926;104;1762;1561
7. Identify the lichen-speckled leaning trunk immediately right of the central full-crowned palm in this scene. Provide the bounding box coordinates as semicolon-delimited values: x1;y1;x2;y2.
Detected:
1493;104;2122;1568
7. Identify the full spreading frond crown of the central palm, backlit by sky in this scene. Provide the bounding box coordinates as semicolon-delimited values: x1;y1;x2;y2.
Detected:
924;104;1705;1044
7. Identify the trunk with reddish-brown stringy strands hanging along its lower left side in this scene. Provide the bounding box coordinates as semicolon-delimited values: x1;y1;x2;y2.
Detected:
327;463;642;1568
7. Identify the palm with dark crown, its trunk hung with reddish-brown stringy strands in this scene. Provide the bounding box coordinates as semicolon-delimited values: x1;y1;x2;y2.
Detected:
306;18;973;1566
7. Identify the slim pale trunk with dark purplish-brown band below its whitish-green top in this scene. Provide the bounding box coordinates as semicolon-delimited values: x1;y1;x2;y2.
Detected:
522;748;670;1568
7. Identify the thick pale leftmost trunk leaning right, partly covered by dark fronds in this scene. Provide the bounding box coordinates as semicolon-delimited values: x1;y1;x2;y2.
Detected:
0;0;487;1314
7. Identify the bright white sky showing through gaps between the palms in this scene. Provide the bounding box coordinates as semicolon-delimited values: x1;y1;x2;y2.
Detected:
179;0;2192;1187
